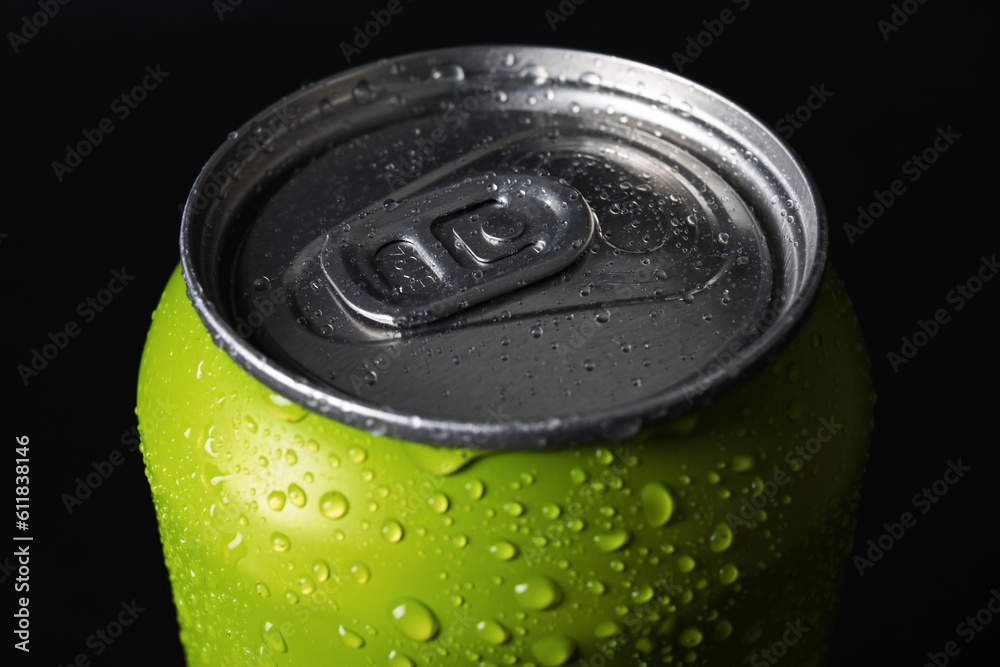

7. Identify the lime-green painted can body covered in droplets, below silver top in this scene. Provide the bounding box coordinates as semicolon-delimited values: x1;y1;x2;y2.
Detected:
137;267;874;667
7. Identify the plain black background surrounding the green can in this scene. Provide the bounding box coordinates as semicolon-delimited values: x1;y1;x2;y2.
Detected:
0;0;1000;665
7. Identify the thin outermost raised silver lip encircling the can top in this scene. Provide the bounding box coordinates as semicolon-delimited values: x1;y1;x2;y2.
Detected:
180;45;829;449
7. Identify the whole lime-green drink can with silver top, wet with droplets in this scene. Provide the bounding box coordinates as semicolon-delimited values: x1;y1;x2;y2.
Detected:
137;47;874;667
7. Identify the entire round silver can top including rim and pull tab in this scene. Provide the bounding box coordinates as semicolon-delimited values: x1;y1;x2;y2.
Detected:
181;47;827;449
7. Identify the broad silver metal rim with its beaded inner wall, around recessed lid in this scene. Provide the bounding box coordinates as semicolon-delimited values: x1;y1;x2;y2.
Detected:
180;46;828;450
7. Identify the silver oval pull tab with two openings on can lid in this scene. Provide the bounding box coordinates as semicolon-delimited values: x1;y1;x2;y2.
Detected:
320;173;595;327
